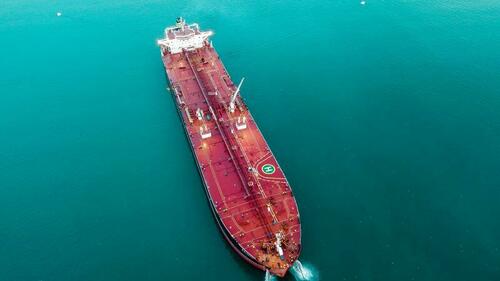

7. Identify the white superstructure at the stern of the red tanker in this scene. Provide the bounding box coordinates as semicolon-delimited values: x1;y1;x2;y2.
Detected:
157;18;213;54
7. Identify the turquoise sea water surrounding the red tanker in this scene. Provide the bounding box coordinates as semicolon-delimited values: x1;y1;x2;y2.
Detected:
0;0;500;281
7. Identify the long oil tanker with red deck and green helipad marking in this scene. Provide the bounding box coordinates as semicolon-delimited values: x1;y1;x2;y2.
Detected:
157;18;301;277
